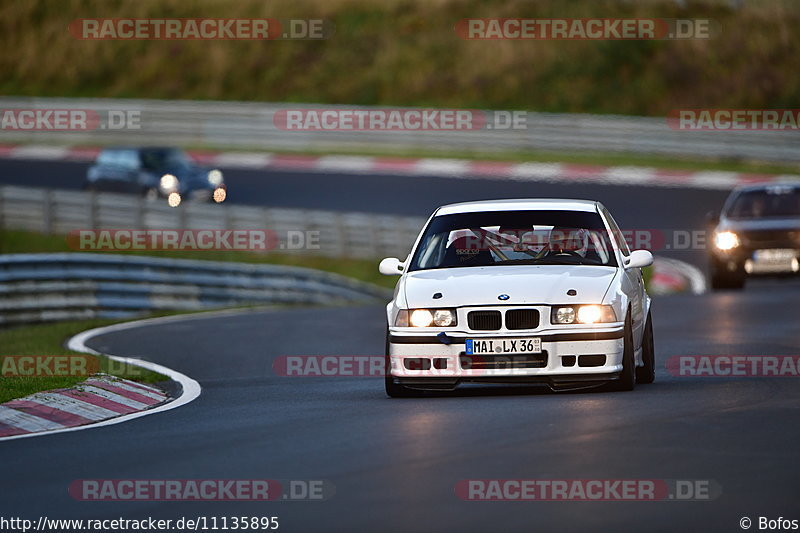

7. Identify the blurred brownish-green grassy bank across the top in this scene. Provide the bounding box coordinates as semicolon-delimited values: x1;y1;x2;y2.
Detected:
0;0;800;116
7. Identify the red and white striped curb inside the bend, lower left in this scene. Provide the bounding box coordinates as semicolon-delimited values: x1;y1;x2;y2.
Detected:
0;374;168;437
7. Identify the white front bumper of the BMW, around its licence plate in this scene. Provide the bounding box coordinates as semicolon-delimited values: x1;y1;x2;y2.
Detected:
389;324;624;387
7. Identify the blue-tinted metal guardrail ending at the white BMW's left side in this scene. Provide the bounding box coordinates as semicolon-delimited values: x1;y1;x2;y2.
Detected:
0;253;391;325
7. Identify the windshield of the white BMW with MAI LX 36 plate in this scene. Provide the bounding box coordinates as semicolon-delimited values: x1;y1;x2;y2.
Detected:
409;211;617;271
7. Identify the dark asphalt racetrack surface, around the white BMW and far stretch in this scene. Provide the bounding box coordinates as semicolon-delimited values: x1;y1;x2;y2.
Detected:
0;156;800;532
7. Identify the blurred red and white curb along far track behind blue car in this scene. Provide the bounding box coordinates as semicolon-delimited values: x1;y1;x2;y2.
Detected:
0;144;800;189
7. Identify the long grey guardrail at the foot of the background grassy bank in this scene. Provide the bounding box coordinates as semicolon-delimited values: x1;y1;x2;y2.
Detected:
0;97;800;162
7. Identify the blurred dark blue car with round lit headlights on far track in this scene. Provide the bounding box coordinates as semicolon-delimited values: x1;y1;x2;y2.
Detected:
84;147;227;207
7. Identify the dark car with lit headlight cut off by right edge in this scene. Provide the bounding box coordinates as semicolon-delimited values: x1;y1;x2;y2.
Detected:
708;183;800;289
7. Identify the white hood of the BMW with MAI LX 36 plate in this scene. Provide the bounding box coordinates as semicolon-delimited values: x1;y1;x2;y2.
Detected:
404;265;617;308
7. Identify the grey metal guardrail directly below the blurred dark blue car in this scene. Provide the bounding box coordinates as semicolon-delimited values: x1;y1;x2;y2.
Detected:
0;185;425;259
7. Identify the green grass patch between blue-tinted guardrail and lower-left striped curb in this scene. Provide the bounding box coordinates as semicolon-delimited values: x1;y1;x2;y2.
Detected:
0;320;169;403
